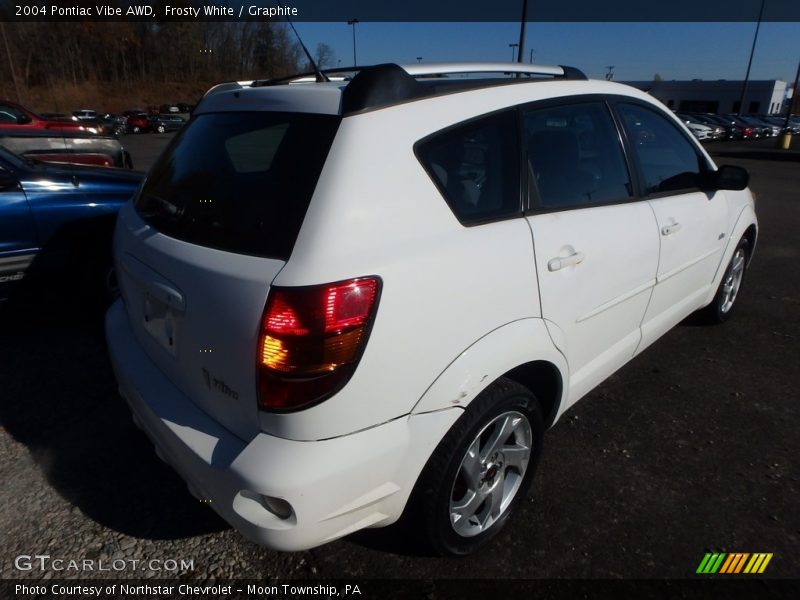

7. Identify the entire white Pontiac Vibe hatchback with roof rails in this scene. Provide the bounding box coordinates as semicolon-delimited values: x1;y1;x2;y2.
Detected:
106;63;757;555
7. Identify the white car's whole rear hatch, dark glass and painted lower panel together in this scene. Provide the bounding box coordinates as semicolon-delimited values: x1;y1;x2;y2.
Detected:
115;111;339;439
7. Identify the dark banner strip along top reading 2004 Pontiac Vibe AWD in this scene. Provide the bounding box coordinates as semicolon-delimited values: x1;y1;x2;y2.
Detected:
0;0;800;22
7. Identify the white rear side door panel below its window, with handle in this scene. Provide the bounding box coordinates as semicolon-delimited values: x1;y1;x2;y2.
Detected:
528;202;658;404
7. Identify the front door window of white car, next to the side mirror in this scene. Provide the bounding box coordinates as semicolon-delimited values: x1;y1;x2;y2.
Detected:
617;103;707;195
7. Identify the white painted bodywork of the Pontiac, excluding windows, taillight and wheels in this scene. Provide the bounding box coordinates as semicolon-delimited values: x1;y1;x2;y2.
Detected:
106;64;756;550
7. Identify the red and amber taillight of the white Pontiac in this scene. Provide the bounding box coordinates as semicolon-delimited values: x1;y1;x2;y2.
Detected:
257;277;380;412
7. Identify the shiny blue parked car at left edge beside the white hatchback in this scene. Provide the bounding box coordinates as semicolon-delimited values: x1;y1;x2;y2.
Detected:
0;147;144;299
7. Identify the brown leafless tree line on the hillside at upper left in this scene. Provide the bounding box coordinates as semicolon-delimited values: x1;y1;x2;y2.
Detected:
0;21;310;88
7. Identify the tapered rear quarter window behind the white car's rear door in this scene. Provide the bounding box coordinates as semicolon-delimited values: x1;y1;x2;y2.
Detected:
417;111;522;224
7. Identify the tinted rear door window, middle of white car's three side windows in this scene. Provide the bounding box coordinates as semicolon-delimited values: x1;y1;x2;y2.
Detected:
523;101;633;210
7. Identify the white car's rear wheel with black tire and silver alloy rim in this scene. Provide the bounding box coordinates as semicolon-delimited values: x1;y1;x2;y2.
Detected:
404;378;544;556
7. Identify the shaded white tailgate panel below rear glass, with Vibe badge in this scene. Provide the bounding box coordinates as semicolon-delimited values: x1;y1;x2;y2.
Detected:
115;204;284;439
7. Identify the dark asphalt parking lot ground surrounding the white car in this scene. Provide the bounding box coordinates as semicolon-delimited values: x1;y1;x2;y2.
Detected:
0;135;800;580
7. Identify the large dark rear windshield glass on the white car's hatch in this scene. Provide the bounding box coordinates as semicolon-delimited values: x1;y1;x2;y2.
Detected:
136;112;340;260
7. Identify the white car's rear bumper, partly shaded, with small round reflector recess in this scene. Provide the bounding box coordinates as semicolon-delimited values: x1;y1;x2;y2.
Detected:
106;301;461;550
